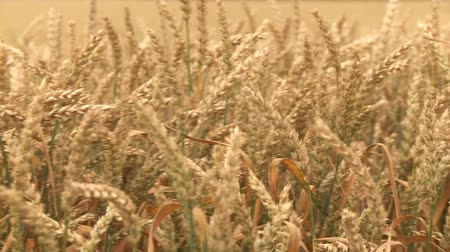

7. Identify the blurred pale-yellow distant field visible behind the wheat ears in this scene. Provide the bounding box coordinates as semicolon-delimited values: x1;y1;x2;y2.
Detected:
0;0;450;42
